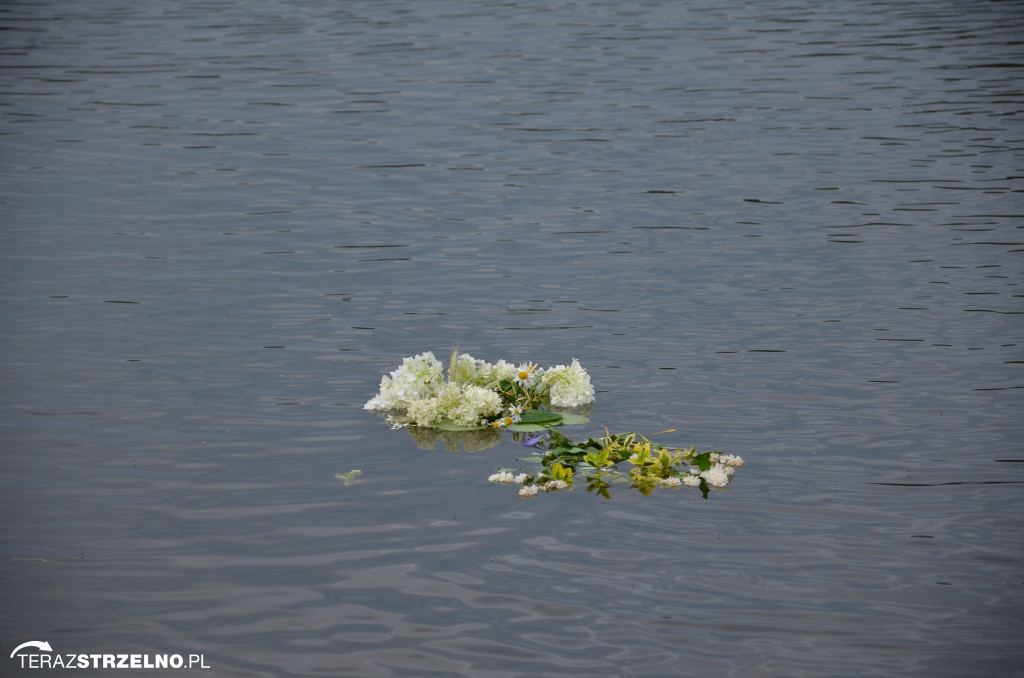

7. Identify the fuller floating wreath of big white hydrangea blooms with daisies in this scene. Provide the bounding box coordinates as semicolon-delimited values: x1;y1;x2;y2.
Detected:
362;351;594;427
